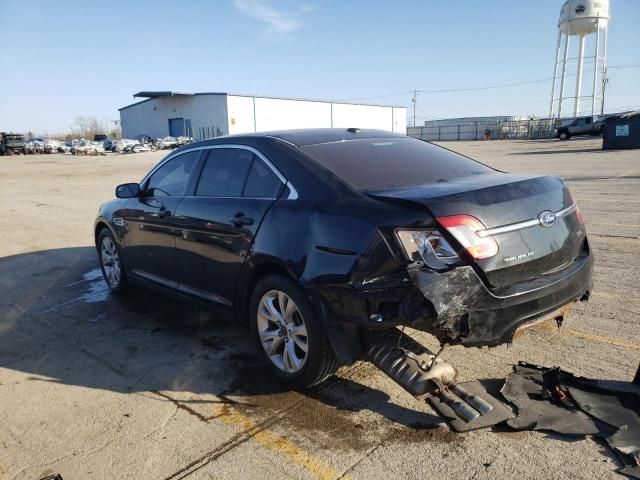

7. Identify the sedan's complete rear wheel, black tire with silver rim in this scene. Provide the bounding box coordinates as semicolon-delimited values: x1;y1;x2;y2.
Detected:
249;275;338;389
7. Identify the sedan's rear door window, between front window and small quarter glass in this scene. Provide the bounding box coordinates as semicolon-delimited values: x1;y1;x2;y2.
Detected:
196;148;254;197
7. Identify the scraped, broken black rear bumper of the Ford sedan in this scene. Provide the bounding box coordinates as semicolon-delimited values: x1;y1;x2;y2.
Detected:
409;249;593;347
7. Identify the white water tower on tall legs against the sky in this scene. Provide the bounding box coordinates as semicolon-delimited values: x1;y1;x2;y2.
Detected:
549;0;609;118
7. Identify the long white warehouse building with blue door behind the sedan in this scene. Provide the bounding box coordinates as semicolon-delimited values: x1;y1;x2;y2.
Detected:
119;92;407;140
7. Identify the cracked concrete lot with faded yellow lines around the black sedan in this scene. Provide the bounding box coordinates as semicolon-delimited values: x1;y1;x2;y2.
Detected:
0;139;640;480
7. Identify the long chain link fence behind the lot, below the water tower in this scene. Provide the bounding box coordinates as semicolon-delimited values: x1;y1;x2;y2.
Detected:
407;118;554;142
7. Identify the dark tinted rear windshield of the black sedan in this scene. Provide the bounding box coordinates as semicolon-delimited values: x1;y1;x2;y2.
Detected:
302;138;494;191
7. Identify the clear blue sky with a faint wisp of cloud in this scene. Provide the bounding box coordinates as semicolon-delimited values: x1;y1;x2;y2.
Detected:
0;0;640;133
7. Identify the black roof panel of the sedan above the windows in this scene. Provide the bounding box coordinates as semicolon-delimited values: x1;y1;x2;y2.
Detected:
182;128;405;147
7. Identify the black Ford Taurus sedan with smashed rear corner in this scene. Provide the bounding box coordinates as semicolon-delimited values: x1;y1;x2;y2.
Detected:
95;129;593;387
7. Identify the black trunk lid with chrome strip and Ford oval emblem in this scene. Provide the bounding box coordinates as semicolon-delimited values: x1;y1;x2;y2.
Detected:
368;172;585;287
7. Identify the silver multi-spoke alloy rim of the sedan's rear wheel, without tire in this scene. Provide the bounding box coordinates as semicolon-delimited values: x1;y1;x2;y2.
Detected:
257;290;309;373
